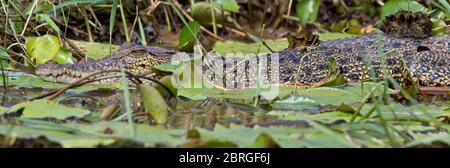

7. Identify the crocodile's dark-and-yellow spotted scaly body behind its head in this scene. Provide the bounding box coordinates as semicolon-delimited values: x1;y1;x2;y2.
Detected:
204;34;450;88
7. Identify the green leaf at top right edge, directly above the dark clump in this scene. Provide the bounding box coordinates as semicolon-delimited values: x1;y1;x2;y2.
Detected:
381;0;426;19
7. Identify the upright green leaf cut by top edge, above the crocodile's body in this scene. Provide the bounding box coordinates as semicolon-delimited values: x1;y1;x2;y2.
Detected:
295;0;320;25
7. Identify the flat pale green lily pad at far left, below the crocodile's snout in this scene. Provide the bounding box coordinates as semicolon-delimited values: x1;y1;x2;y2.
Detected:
10;100;90;120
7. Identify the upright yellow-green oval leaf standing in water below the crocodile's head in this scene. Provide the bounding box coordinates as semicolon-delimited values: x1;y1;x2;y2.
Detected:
138;85;169;124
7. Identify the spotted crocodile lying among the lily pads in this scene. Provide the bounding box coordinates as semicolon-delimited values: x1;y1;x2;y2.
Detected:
36;13;450;88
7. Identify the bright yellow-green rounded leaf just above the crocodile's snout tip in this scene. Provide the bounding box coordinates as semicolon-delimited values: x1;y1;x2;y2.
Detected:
25;35;61;65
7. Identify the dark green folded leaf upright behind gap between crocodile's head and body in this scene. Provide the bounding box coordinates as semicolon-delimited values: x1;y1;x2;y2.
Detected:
177;21;200;51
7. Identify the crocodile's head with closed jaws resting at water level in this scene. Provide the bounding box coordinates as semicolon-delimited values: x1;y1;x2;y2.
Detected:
35;45;176;83
